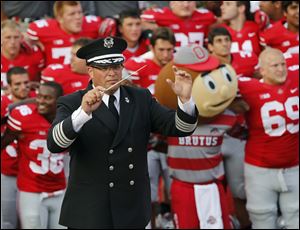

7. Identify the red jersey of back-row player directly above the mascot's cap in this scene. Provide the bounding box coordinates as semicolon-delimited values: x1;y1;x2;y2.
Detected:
141;7;216;47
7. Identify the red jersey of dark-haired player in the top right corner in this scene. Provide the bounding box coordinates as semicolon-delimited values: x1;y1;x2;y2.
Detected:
260;21;299;53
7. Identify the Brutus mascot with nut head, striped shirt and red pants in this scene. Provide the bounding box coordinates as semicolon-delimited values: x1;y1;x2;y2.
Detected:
155;45;237;229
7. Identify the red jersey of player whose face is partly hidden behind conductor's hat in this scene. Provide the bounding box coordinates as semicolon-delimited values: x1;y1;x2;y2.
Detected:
41;64;90;95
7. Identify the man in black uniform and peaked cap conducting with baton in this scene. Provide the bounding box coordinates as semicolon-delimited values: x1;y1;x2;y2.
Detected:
47;37;198;229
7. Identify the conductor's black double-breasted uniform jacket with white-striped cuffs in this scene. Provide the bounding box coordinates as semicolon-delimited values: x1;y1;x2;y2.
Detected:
47;82;197;229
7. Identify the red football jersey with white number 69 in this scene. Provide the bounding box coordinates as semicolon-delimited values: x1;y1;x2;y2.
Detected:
238;76;299;168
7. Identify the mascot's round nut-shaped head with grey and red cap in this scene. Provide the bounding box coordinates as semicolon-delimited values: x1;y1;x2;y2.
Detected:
155;44;237;117
